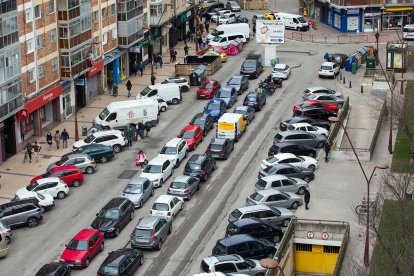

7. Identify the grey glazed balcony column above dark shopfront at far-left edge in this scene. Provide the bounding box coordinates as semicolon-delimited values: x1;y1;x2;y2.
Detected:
0;0;23;163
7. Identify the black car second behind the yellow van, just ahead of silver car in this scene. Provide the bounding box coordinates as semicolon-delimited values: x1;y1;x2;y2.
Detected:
184;154;216;181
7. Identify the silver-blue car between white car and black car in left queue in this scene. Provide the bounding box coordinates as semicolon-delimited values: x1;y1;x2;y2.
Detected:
121;176;154;208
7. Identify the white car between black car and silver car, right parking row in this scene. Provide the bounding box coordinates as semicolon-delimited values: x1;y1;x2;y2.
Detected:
260;153;318;171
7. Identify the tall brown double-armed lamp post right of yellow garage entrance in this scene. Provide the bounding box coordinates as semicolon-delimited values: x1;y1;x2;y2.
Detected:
328;117;388;267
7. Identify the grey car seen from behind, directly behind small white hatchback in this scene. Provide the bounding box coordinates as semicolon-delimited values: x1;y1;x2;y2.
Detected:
131;216;172;250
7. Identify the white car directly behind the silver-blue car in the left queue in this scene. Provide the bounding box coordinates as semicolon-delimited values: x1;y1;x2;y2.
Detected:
140;156;174;187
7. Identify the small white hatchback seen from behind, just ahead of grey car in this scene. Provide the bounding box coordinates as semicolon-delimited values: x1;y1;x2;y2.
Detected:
150;195;184;219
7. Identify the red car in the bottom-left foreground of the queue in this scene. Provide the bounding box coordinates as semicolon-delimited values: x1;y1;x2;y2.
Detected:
60;229;104;268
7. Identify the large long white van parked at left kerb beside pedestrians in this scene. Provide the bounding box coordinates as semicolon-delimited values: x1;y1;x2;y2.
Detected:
94;98;159;129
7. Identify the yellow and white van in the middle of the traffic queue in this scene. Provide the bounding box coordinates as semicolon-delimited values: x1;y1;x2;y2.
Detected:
216;113;246;142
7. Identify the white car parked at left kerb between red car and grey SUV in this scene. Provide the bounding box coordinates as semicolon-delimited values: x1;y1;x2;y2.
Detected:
17;177;69;199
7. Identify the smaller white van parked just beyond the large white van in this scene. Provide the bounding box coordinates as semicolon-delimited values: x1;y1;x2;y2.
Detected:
136;83;182;104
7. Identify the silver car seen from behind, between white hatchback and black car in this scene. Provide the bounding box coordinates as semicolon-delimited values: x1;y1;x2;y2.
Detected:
167;175;200;200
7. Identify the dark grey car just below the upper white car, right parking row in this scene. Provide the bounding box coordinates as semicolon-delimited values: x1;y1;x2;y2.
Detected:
273;130;326;149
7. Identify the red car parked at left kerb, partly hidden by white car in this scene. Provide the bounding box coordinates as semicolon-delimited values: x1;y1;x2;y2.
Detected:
30;166;83;187
